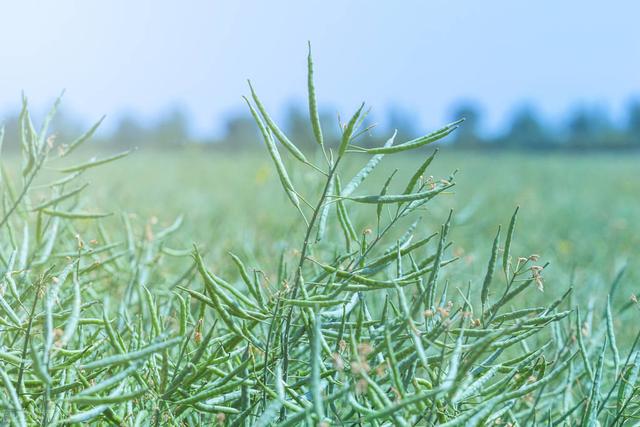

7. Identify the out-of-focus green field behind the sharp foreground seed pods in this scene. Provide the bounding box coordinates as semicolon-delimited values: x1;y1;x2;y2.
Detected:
91;149;640;310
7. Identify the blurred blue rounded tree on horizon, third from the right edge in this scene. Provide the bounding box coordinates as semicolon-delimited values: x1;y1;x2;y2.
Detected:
502;106;554;149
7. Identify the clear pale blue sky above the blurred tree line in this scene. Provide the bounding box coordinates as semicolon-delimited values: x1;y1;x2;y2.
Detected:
0;0;640;135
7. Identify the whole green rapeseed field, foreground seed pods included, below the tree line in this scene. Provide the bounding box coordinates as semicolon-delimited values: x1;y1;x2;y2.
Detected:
0;106;640;427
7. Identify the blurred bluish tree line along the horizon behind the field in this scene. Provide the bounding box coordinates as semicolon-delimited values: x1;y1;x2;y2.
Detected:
0;100;640;151
